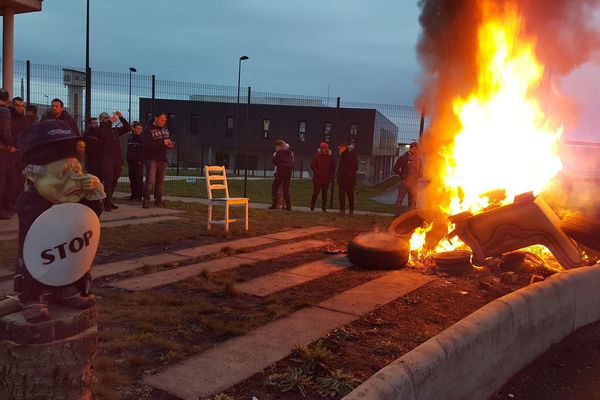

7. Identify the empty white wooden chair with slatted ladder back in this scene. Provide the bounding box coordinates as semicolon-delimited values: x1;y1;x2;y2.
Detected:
204;165;249;233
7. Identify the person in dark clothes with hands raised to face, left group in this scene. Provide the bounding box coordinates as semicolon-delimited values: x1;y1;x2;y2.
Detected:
96;111;131;211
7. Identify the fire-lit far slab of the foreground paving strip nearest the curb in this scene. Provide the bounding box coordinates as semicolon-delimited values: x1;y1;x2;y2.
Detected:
319;270;433;316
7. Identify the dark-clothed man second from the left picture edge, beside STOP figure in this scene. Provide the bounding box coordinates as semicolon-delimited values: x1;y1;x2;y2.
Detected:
0;97;32;218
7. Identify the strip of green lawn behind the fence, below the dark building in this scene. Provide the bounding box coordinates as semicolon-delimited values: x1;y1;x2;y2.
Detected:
117;177;397;213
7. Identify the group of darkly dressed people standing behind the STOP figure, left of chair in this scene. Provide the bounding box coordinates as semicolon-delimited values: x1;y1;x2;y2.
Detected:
0;89;175;219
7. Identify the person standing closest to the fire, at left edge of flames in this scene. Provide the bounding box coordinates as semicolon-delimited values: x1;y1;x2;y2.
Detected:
393;142;423;215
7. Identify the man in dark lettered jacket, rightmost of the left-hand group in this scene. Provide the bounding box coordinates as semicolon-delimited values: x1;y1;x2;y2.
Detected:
142;112;175;208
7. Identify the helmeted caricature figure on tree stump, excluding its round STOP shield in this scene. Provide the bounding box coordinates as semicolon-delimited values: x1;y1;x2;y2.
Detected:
14;120;105;323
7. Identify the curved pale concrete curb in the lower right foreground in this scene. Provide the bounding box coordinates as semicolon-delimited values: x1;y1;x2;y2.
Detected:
344;264;600;400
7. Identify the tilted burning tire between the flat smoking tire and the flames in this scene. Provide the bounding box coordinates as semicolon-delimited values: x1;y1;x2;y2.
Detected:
388;208;448;248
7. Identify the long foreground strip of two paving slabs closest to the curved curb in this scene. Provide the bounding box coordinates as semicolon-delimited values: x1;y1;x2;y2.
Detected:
145;270;433;400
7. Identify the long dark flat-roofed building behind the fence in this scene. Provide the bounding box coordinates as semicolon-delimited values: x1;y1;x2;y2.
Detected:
140;98;398;184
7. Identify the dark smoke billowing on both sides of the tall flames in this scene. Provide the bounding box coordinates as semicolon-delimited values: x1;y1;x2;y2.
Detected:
416;0;600;212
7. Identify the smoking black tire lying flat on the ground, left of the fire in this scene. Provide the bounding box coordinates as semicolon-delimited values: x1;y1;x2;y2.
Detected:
348;233;410;269
